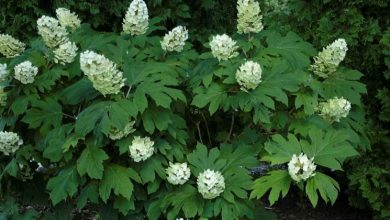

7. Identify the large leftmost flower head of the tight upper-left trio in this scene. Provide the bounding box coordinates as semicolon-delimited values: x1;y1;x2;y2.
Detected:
37;16;68;48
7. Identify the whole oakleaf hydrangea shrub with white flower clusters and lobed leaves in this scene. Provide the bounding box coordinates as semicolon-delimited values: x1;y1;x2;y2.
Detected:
0;0;369;220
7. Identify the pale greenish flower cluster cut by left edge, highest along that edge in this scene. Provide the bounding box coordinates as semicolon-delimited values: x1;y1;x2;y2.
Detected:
0;34;26;58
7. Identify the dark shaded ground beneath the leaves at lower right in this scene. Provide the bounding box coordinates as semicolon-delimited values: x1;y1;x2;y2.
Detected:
270;190;372;220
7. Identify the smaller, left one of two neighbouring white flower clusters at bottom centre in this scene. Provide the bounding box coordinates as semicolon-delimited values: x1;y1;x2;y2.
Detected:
166;162;191;185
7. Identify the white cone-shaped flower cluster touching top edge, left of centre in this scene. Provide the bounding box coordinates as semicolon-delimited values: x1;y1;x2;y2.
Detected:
122;0;149;35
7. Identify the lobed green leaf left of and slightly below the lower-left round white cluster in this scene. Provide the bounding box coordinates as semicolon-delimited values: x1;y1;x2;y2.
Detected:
77;144;109;179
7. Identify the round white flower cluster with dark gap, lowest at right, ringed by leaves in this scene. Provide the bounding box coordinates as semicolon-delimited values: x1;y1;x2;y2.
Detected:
288;153;316;182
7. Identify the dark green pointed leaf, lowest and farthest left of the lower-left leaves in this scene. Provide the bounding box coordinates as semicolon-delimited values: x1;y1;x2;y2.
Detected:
47;166;79;205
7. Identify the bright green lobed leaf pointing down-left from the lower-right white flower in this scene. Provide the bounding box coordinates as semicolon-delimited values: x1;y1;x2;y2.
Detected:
250;170;291;205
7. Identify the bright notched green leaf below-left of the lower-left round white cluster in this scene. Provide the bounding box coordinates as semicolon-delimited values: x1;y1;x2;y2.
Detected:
99;164;133;203
